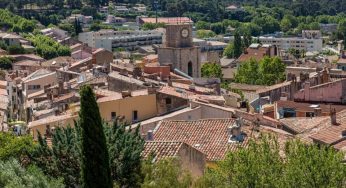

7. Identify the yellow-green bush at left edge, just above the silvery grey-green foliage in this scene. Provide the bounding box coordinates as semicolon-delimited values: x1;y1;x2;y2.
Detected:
0;132;35;160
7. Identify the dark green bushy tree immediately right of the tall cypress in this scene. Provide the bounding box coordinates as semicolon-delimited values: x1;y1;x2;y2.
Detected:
104;122;144;187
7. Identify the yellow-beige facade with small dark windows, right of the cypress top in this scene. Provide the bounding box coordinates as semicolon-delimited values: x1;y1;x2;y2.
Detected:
98;94;157;124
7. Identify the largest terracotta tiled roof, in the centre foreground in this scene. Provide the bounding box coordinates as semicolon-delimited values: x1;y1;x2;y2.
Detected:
154;119;238;161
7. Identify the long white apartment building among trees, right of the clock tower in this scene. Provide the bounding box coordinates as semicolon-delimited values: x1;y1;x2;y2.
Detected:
259;30;323;52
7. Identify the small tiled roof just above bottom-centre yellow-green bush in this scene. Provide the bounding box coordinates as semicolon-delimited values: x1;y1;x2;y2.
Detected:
142;141;184;160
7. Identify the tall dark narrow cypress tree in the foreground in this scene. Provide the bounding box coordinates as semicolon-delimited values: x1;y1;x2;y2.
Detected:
79;86;112;188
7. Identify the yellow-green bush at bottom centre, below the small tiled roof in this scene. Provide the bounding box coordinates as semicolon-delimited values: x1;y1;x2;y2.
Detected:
141;158;192;188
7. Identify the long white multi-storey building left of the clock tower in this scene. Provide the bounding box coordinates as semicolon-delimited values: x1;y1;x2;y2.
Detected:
78;30;163;51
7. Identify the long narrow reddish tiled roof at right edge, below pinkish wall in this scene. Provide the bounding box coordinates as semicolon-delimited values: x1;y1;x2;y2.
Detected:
276;100;346;113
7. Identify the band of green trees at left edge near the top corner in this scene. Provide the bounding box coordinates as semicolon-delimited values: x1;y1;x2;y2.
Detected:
0;9;36;32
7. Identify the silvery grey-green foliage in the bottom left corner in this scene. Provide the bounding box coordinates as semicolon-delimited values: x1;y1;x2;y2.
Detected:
0;159;65;188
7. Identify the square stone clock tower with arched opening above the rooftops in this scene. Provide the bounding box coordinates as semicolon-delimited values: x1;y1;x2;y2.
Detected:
158;23;201;78
